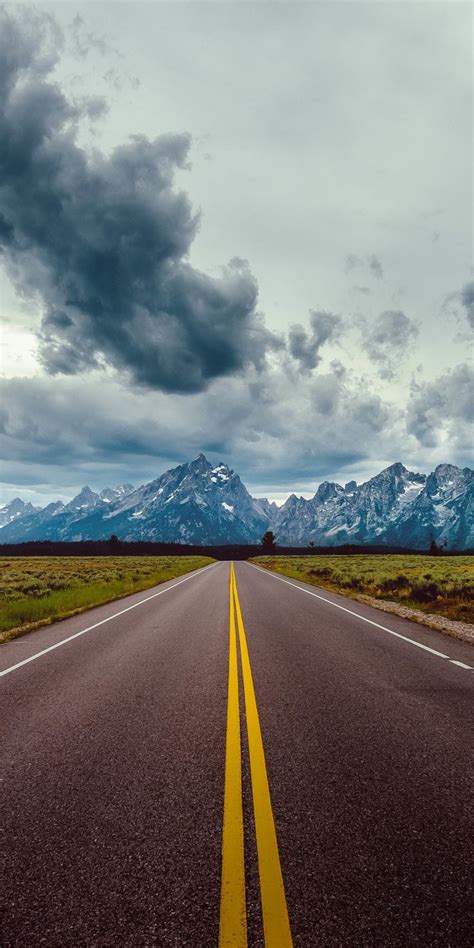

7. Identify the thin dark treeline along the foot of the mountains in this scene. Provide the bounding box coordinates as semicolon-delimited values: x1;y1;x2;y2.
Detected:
0;536;474;560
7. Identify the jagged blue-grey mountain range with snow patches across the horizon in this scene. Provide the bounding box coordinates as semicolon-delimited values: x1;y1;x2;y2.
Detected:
0;454;474;550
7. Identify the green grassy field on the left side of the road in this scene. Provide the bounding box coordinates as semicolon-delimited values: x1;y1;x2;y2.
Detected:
0;556;212;642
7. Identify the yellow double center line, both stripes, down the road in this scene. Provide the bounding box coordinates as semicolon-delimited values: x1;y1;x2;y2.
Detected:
219;563;293;948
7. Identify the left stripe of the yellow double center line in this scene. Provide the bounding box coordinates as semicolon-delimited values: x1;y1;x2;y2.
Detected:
219;567;247;948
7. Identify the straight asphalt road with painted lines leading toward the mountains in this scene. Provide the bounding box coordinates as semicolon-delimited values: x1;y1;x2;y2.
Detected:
0;563;474;948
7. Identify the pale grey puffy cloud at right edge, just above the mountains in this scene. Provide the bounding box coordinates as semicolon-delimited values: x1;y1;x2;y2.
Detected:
406;364;474;456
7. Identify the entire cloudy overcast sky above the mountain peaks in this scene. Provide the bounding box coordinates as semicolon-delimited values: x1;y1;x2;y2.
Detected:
0;0;474;503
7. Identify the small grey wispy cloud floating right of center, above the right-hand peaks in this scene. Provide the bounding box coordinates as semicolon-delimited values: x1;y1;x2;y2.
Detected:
360;310;418;379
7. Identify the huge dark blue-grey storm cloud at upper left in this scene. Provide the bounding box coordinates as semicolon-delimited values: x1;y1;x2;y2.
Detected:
0;9;281;392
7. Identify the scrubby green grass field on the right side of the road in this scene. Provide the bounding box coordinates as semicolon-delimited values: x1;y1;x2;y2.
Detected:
254;554;474;623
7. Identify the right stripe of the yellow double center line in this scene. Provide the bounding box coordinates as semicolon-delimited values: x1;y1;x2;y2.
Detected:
231;564;293;948
